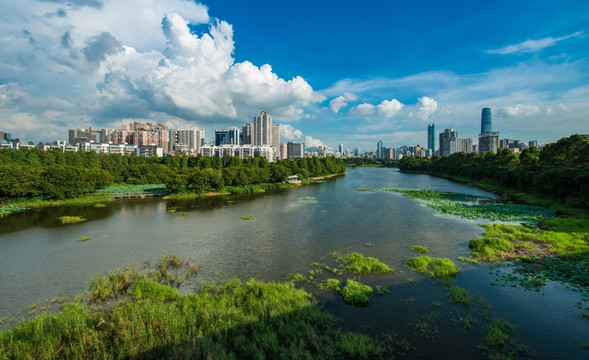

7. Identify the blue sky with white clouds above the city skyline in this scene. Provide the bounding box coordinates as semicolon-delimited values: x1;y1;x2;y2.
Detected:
0;0;589;152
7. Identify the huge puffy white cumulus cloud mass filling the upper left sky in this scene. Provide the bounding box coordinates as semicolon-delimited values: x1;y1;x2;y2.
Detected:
0;0;322;140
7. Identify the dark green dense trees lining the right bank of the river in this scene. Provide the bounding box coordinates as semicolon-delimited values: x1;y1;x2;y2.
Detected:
399;135;589;208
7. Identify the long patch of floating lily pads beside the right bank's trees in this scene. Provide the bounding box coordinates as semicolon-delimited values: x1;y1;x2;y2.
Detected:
380;189;556;224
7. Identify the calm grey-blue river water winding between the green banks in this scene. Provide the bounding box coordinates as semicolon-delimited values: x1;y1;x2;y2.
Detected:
0;168;589;359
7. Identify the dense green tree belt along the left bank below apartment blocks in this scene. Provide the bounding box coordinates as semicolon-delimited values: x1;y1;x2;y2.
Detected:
0;148;345;200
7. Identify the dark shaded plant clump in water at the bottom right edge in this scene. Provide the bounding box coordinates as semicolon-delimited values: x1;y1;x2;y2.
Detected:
480;319;529;359
